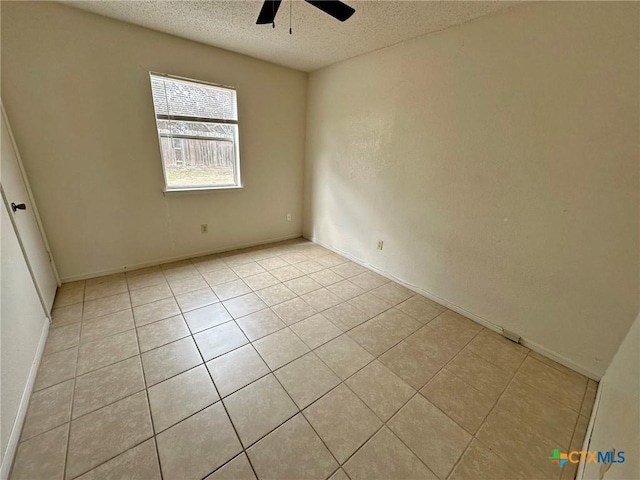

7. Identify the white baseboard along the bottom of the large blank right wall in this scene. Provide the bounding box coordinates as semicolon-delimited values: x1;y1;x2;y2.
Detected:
303;235;602;381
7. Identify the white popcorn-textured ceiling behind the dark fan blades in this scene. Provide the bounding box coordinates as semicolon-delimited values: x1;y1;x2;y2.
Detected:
63;0;516;71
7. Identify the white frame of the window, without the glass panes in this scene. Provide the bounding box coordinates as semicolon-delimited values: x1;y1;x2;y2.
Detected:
149;71;243;193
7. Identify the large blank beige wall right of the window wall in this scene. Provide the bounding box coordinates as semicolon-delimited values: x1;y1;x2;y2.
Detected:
304;2;639;377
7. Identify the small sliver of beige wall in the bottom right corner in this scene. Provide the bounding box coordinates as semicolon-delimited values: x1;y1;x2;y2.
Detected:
583;316;640;480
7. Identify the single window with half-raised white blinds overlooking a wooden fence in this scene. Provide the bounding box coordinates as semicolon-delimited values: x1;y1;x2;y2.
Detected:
150;73;242;191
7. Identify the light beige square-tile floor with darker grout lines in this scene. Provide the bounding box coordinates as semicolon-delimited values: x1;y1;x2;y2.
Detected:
11;239;596;480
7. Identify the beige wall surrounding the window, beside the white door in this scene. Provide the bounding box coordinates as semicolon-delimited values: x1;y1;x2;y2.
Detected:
1;2;307;279
